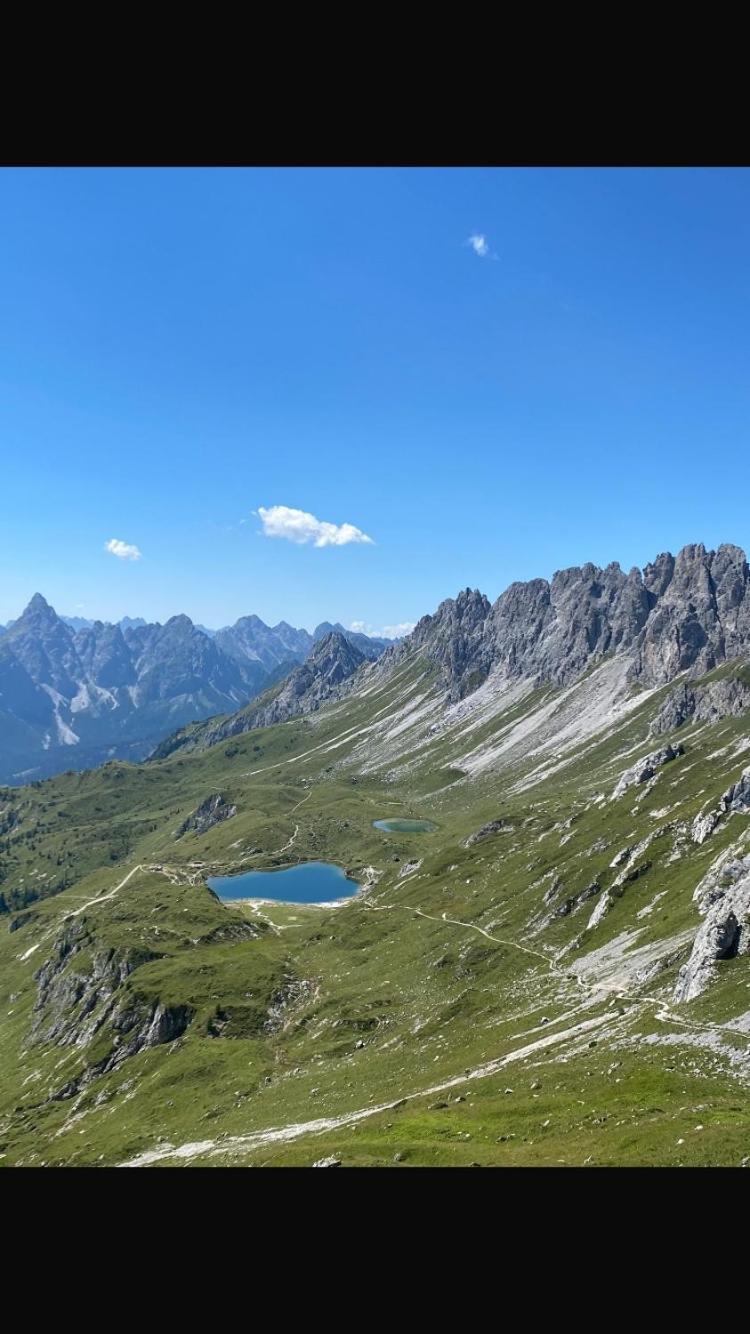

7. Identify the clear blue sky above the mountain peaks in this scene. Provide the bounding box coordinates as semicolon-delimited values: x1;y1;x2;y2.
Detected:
0;168;750;630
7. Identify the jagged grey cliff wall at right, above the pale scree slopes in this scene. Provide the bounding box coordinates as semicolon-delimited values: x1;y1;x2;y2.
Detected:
383;546;750;700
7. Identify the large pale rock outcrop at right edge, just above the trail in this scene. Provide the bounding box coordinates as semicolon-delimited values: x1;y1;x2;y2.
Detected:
674;856;750;1001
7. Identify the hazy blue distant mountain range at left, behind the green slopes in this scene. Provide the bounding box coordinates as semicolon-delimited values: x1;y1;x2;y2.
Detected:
0;594;388;783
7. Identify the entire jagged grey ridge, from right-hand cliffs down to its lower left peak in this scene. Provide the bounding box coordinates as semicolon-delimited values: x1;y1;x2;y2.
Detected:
155;544;750;758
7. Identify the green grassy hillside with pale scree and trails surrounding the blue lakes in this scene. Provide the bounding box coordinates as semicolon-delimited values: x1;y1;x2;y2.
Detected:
0;652;750;1166
